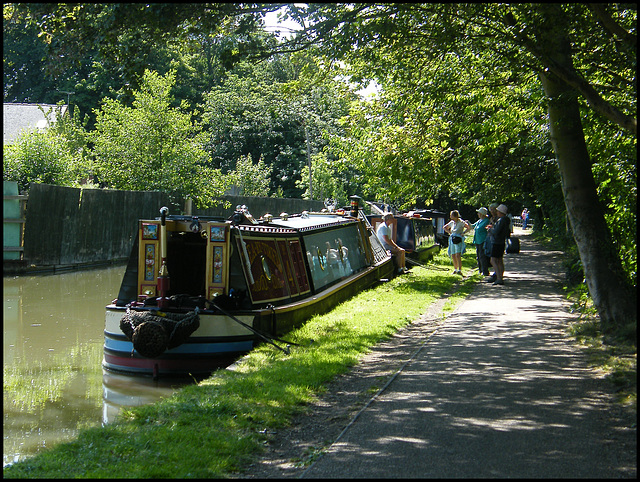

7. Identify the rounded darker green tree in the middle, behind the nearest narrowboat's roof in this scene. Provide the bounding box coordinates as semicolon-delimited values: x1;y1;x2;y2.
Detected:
203;55;348;197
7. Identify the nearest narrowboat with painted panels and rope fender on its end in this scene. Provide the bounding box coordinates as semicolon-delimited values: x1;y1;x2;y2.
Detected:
103;201;393;378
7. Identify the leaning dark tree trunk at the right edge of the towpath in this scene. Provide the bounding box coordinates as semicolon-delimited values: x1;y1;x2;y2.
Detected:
540;10;637;332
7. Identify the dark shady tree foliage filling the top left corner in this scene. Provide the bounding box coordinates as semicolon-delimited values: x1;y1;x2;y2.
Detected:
3;3;280;128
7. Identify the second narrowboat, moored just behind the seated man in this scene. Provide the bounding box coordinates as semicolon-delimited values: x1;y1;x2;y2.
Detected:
367;211;440;262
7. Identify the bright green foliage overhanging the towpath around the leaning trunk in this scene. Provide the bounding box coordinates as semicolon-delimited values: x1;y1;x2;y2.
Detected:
293;4;637;326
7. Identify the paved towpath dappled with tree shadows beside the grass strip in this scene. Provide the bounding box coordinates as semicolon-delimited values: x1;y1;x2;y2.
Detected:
248;230;637;479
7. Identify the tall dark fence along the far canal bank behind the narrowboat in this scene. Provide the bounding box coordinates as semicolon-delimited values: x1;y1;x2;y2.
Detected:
24;184;324;266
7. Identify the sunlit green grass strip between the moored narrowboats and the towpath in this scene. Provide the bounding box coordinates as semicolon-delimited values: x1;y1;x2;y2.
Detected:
4;251;478;478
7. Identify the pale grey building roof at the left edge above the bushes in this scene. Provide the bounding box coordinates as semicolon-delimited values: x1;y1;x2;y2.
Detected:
2;103;68;144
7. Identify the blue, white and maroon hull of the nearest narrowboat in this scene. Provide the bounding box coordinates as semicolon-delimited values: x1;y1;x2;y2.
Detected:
103;259;393;377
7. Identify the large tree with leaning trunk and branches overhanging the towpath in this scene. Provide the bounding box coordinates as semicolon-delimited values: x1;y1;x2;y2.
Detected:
289;4;637;331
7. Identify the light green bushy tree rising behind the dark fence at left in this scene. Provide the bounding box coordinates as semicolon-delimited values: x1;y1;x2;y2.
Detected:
93;71;224;207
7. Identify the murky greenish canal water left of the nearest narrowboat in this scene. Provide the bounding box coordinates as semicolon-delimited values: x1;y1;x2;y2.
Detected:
3;266;195;466
